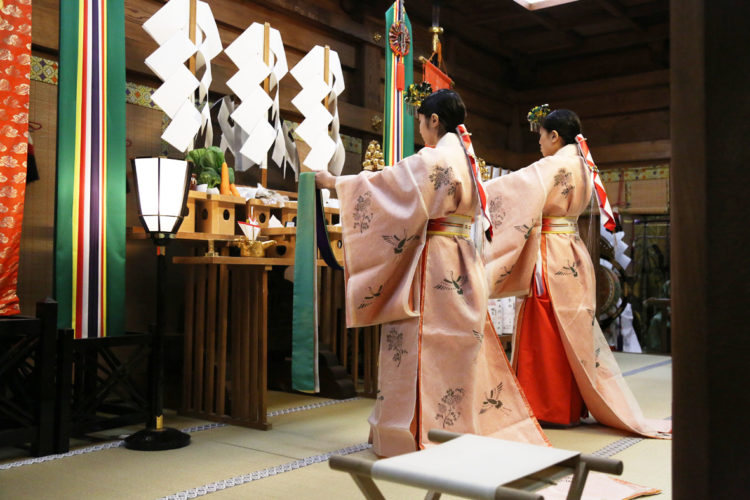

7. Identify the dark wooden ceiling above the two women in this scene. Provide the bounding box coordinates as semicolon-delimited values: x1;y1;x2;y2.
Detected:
364;0;669;88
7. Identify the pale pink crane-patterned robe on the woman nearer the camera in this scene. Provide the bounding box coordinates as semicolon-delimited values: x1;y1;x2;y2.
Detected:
336;133;547;456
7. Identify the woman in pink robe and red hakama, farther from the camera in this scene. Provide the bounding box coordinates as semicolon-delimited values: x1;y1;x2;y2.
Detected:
484;110;671;437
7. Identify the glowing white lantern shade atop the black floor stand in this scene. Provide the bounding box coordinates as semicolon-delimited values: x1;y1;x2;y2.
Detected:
133;158;190;234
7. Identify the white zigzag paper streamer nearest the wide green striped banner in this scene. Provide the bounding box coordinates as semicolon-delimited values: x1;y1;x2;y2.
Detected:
143;0;222;152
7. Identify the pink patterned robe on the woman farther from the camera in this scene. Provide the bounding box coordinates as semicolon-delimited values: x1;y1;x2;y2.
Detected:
484;145;672;437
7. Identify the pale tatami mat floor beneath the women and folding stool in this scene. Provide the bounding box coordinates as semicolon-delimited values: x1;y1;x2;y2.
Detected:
0;353;672;500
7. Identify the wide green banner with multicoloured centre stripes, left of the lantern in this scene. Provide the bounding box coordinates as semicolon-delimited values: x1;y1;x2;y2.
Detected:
55;0;126;338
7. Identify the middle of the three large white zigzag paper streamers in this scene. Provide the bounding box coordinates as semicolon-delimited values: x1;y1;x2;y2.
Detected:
222;23;294;178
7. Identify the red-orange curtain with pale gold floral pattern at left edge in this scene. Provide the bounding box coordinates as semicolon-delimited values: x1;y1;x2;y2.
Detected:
0;0;31;316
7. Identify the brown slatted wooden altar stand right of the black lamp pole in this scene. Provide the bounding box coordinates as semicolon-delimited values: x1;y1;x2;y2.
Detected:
173;256;344;430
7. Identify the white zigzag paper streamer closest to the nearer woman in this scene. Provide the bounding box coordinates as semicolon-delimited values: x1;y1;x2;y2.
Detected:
290;45;345;175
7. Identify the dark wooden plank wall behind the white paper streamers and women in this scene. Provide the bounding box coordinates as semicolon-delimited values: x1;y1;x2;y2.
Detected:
33;0;669;170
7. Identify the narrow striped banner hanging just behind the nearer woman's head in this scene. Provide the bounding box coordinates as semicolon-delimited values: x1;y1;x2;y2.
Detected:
383;0;414;165
